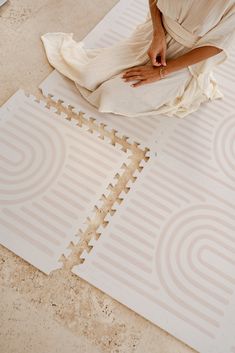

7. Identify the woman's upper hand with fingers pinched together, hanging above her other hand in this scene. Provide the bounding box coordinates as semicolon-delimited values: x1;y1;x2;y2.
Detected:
147;28;166;66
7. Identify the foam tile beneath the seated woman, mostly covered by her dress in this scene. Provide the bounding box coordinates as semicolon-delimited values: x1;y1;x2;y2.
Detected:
40;0;235;147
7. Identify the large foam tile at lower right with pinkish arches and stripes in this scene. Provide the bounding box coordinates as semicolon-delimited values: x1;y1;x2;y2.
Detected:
73;69;235;353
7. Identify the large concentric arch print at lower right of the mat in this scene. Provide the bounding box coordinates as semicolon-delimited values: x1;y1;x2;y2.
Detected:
155;204;235;327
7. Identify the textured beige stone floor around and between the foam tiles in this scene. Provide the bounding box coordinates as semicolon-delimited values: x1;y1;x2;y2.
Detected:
0;0;196;353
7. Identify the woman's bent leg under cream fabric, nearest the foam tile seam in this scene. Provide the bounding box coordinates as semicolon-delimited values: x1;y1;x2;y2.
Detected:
77;64;192;117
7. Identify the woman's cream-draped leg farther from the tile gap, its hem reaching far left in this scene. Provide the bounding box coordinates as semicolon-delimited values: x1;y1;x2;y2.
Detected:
42;11;152;91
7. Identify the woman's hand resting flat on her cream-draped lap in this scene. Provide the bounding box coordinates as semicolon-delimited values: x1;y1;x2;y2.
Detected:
122;65;161;87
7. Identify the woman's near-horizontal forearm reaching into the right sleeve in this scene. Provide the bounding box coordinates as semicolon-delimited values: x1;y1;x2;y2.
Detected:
165;46;222;75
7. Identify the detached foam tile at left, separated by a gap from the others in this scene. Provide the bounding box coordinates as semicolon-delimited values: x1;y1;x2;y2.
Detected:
0;91;130;273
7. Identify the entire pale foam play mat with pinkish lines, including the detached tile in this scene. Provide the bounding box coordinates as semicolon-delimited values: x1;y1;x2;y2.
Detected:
0;0;235;353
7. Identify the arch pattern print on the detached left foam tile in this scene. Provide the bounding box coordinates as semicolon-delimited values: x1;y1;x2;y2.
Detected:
0;104;67;205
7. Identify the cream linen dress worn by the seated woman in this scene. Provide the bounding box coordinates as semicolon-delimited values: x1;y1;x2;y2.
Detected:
41;0;235;118
